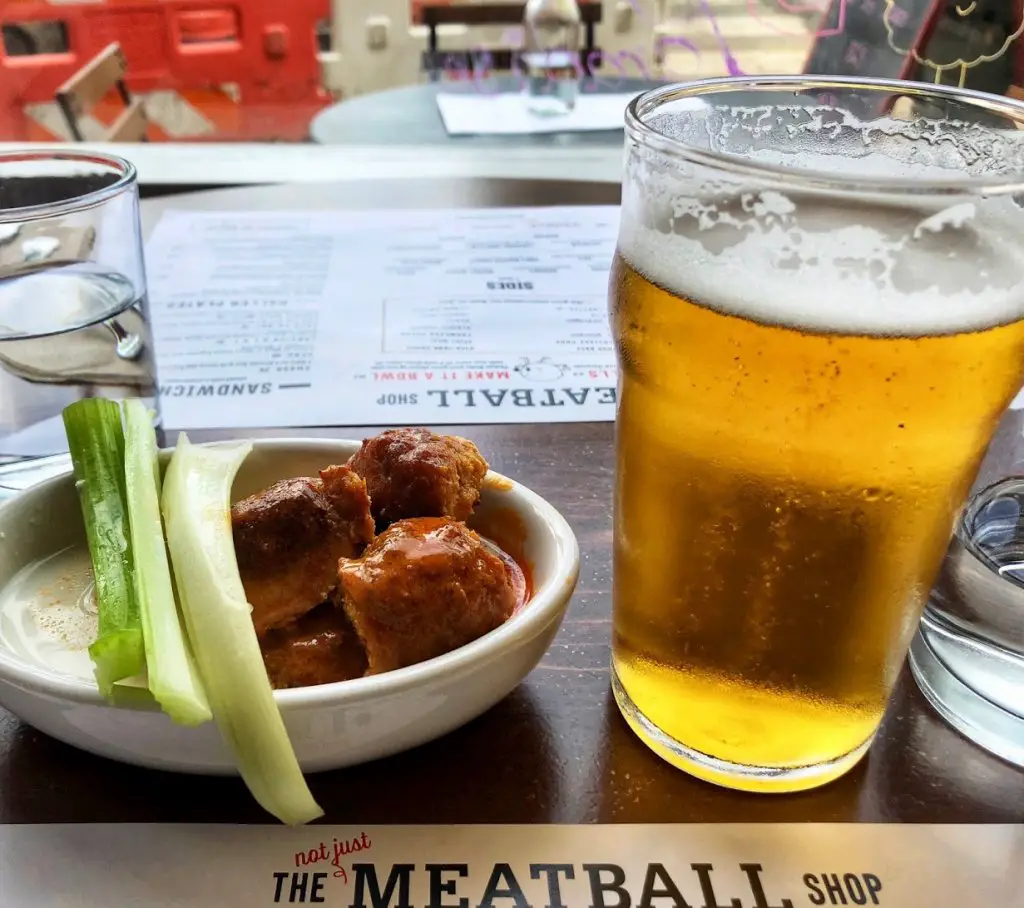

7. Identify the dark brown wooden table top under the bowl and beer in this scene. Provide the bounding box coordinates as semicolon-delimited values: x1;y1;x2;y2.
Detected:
0;181;1024;824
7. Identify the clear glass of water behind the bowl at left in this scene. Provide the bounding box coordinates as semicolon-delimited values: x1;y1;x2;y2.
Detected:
0;149;157;479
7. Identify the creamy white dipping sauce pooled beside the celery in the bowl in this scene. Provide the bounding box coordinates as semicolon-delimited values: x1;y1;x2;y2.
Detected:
0;546;99;681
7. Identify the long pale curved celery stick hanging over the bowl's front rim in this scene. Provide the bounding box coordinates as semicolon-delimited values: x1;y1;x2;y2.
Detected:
161;433;323;825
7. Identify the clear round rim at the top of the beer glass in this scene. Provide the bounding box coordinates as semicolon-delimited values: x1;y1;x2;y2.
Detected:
626;75;1024;198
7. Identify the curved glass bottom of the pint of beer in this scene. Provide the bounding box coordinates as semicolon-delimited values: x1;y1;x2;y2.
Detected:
611;666;874;794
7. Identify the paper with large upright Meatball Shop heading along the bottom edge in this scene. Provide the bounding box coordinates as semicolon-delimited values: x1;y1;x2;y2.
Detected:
0;823;1022;908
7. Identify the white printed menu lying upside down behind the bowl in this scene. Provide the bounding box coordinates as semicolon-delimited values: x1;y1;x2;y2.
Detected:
146;206;618;429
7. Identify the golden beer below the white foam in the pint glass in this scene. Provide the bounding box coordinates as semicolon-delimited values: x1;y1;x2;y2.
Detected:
610;255;1024;790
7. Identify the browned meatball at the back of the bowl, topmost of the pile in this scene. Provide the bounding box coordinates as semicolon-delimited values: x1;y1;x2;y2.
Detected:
348;429;487;529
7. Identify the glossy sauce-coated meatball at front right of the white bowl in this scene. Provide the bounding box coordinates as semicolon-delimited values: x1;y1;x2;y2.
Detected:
338;517;517;675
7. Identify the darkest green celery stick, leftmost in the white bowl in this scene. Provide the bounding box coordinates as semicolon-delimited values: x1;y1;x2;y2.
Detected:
63;398;145;698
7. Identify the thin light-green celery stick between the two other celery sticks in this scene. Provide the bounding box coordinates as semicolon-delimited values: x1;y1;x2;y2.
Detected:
122;400;212;726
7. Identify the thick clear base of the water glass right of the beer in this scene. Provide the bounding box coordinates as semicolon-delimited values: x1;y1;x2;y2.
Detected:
909;615;1024;767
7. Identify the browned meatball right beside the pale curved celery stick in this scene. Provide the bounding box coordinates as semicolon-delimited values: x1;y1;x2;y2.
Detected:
231;466;374;634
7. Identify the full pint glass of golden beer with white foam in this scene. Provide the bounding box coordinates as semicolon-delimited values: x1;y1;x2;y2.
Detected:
609;77;1024;791
